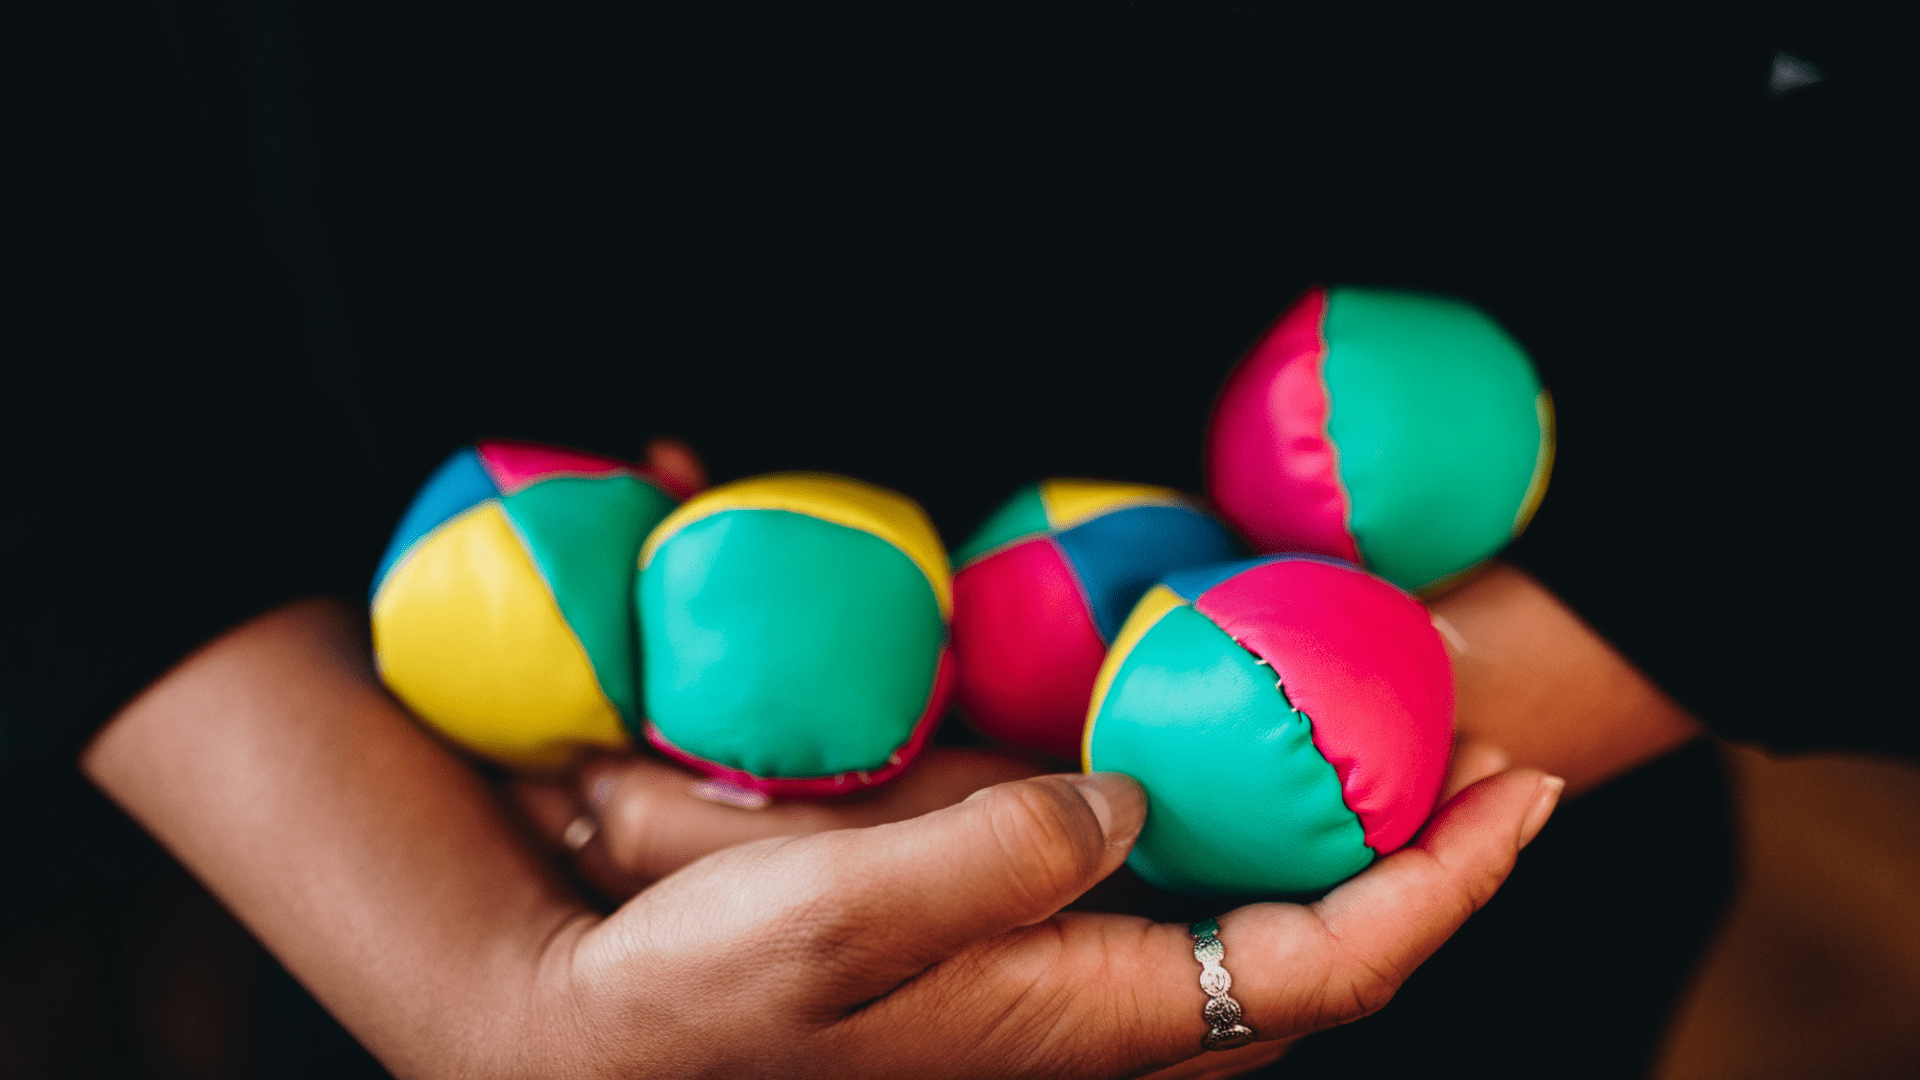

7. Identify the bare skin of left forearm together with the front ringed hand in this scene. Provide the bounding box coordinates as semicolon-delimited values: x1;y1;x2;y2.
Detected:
83;600;1561;1078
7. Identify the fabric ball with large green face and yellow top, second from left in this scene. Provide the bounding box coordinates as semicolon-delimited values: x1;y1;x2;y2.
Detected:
637;473;952;796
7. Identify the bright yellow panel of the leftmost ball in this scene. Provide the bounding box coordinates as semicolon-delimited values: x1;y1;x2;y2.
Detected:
372;500;630;769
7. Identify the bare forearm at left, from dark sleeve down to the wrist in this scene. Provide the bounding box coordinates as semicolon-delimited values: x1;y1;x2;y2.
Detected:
83;601;591;1076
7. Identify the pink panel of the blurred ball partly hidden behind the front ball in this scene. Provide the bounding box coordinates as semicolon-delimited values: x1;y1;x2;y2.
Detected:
952;536;1106;757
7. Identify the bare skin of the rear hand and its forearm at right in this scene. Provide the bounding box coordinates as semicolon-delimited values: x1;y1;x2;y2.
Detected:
515;553;1701;1076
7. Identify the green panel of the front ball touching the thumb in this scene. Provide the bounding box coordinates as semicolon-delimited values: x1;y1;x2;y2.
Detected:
1091;607;1373;896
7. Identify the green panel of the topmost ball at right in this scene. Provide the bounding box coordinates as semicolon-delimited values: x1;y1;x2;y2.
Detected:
1327;288;1540;590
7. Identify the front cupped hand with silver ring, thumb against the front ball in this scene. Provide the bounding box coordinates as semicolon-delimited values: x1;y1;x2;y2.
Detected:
536;771;1561;1080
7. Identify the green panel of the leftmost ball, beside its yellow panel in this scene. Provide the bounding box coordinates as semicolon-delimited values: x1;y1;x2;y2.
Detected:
501;477;674;724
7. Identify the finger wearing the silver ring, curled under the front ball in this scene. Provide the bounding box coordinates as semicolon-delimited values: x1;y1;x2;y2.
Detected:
845;771;1561;1074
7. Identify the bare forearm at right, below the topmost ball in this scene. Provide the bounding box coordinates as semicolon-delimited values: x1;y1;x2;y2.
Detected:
1432;565;1701;792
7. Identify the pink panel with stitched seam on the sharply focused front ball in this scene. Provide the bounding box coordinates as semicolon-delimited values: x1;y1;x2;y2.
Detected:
1194;559;1453;855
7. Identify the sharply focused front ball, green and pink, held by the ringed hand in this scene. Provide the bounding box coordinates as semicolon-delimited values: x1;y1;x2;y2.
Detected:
1085;555;1453;894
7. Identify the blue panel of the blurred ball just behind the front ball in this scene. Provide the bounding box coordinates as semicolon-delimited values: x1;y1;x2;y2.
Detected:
1054;505;1240;644
